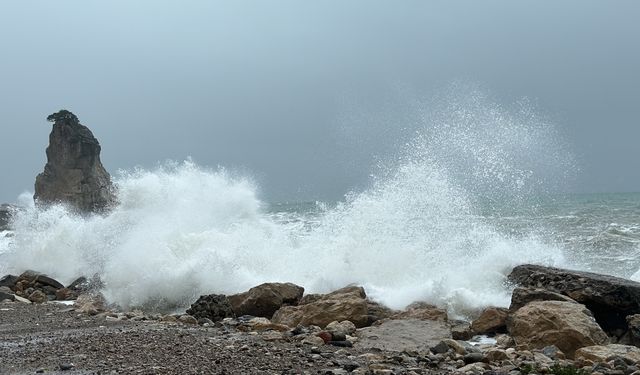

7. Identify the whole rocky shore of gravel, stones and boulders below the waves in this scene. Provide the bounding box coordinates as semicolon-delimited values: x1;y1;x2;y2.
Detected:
0;265;640;375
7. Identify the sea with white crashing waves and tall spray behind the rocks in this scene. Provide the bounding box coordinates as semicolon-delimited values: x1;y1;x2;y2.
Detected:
0;93;640;317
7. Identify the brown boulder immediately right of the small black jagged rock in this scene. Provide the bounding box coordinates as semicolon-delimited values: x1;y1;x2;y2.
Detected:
228;283;304;319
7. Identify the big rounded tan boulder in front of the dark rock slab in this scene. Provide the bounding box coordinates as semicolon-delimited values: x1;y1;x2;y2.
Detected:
507;301;608;358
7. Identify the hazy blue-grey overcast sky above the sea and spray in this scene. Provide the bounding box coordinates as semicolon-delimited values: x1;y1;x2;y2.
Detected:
0;0;640;202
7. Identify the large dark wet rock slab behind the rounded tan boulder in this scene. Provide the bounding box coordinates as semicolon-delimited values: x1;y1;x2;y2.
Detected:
509;264;640;333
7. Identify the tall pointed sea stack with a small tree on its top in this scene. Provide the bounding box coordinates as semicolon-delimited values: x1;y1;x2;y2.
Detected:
33;109;115;214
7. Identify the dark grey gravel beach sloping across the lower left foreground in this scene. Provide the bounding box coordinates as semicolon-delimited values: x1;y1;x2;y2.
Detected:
0;302;436;374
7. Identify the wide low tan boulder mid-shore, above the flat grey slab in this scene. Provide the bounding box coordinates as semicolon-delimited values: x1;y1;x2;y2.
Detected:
271;287;370;328
